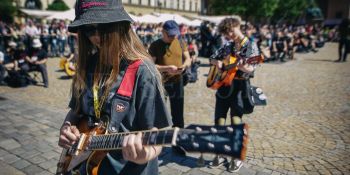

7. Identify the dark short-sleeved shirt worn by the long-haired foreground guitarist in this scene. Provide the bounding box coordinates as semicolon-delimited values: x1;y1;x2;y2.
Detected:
69;56;172;175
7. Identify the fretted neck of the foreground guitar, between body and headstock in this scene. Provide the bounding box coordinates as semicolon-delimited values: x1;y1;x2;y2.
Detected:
87;128;179;150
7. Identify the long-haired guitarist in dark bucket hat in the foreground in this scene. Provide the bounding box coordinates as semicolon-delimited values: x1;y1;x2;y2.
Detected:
58;0;171;175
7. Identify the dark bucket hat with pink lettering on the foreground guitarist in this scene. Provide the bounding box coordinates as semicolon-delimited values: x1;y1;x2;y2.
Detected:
68;0;133;33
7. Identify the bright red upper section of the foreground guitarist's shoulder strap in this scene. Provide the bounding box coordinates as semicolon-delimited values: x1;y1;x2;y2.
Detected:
117;60;142;98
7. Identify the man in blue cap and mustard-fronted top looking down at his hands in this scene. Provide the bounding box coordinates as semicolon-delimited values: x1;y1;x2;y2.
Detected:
148;20;191;128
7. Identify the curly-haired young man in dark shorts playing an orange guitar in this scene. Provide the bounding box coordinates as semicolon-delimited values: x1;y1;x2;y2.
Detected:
210;17;259;172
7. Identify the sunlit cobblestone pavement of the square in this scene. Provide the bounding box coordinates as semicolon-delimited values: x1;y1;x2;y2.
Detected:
0;43;350;175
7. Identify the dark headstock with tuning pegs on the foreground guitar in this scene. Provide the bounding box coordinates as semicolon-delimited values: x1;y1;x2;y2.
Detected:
176;124;248;160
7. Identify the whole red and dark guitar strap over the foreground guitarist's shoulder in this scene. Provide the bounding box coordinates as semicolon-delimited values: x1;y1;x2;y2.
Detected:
108;60;142;133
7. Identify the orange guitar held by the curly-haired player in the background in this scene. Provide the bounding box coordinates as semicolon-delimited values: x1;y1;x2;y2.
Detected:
207;54;264;89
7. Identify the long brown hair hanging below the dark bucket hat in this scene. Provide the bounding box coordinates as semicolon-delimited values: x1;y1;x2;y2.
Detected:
72;21;151;112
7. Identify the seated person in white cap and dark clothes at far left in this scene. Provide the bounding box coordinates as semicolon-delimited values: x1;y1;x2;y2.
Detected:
21;38;49;88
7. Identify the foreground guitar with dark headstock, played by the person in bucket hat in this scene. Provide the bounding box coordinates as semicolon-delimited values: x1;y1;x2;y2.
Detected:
56;121;248;175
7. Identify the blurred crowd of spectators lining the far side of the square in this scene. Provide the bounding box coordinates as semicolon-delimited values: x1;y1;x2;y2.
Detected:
0;15;346;87
